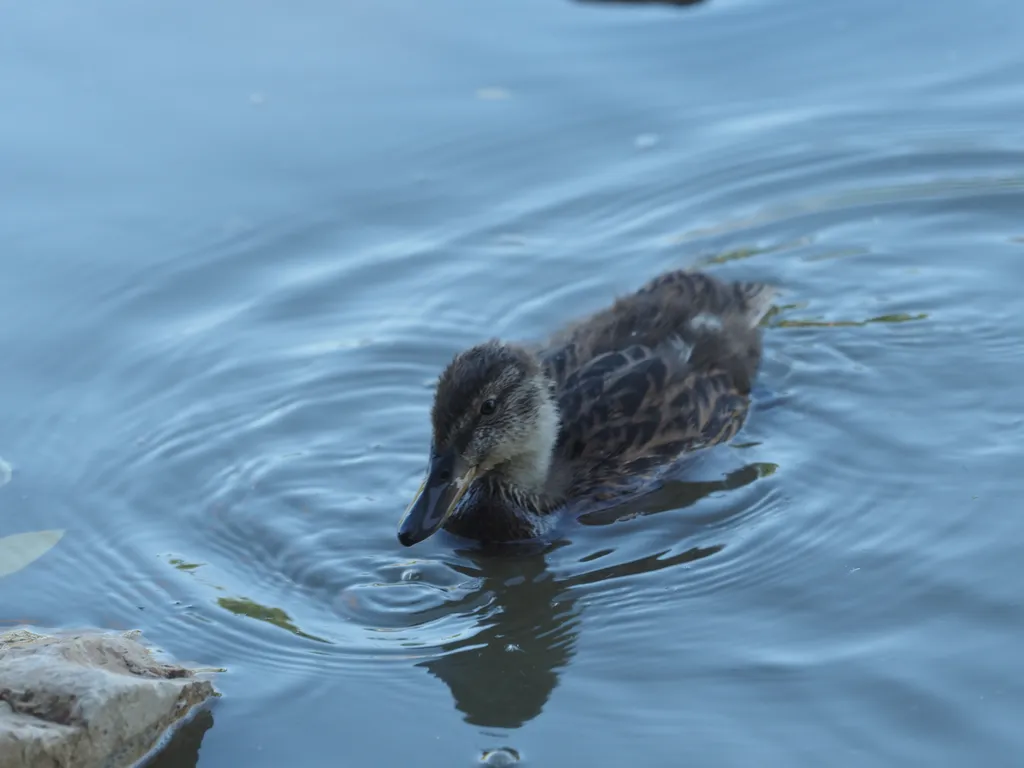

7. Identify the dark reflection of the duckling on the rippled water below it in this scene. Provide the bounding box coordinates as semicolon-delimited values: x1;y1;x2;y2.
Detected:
417;464;774;729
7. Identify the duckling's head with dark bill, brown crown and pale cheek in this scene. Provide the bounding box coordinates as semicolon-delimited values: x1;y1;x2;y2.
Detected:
398;341;558;547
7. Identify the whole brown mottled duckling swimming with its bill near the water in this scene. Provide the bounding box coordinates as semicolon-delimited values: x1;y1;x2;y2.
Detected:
398;270;775;547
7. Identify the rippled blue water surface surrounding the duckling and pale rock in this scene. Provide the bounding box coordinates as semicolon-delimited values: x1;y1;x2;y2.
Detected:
0;0;1024;768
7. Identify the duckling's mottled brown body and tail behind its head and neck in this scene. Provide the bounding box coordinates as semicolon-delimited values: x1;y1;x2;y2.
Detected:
541;270;775;495
